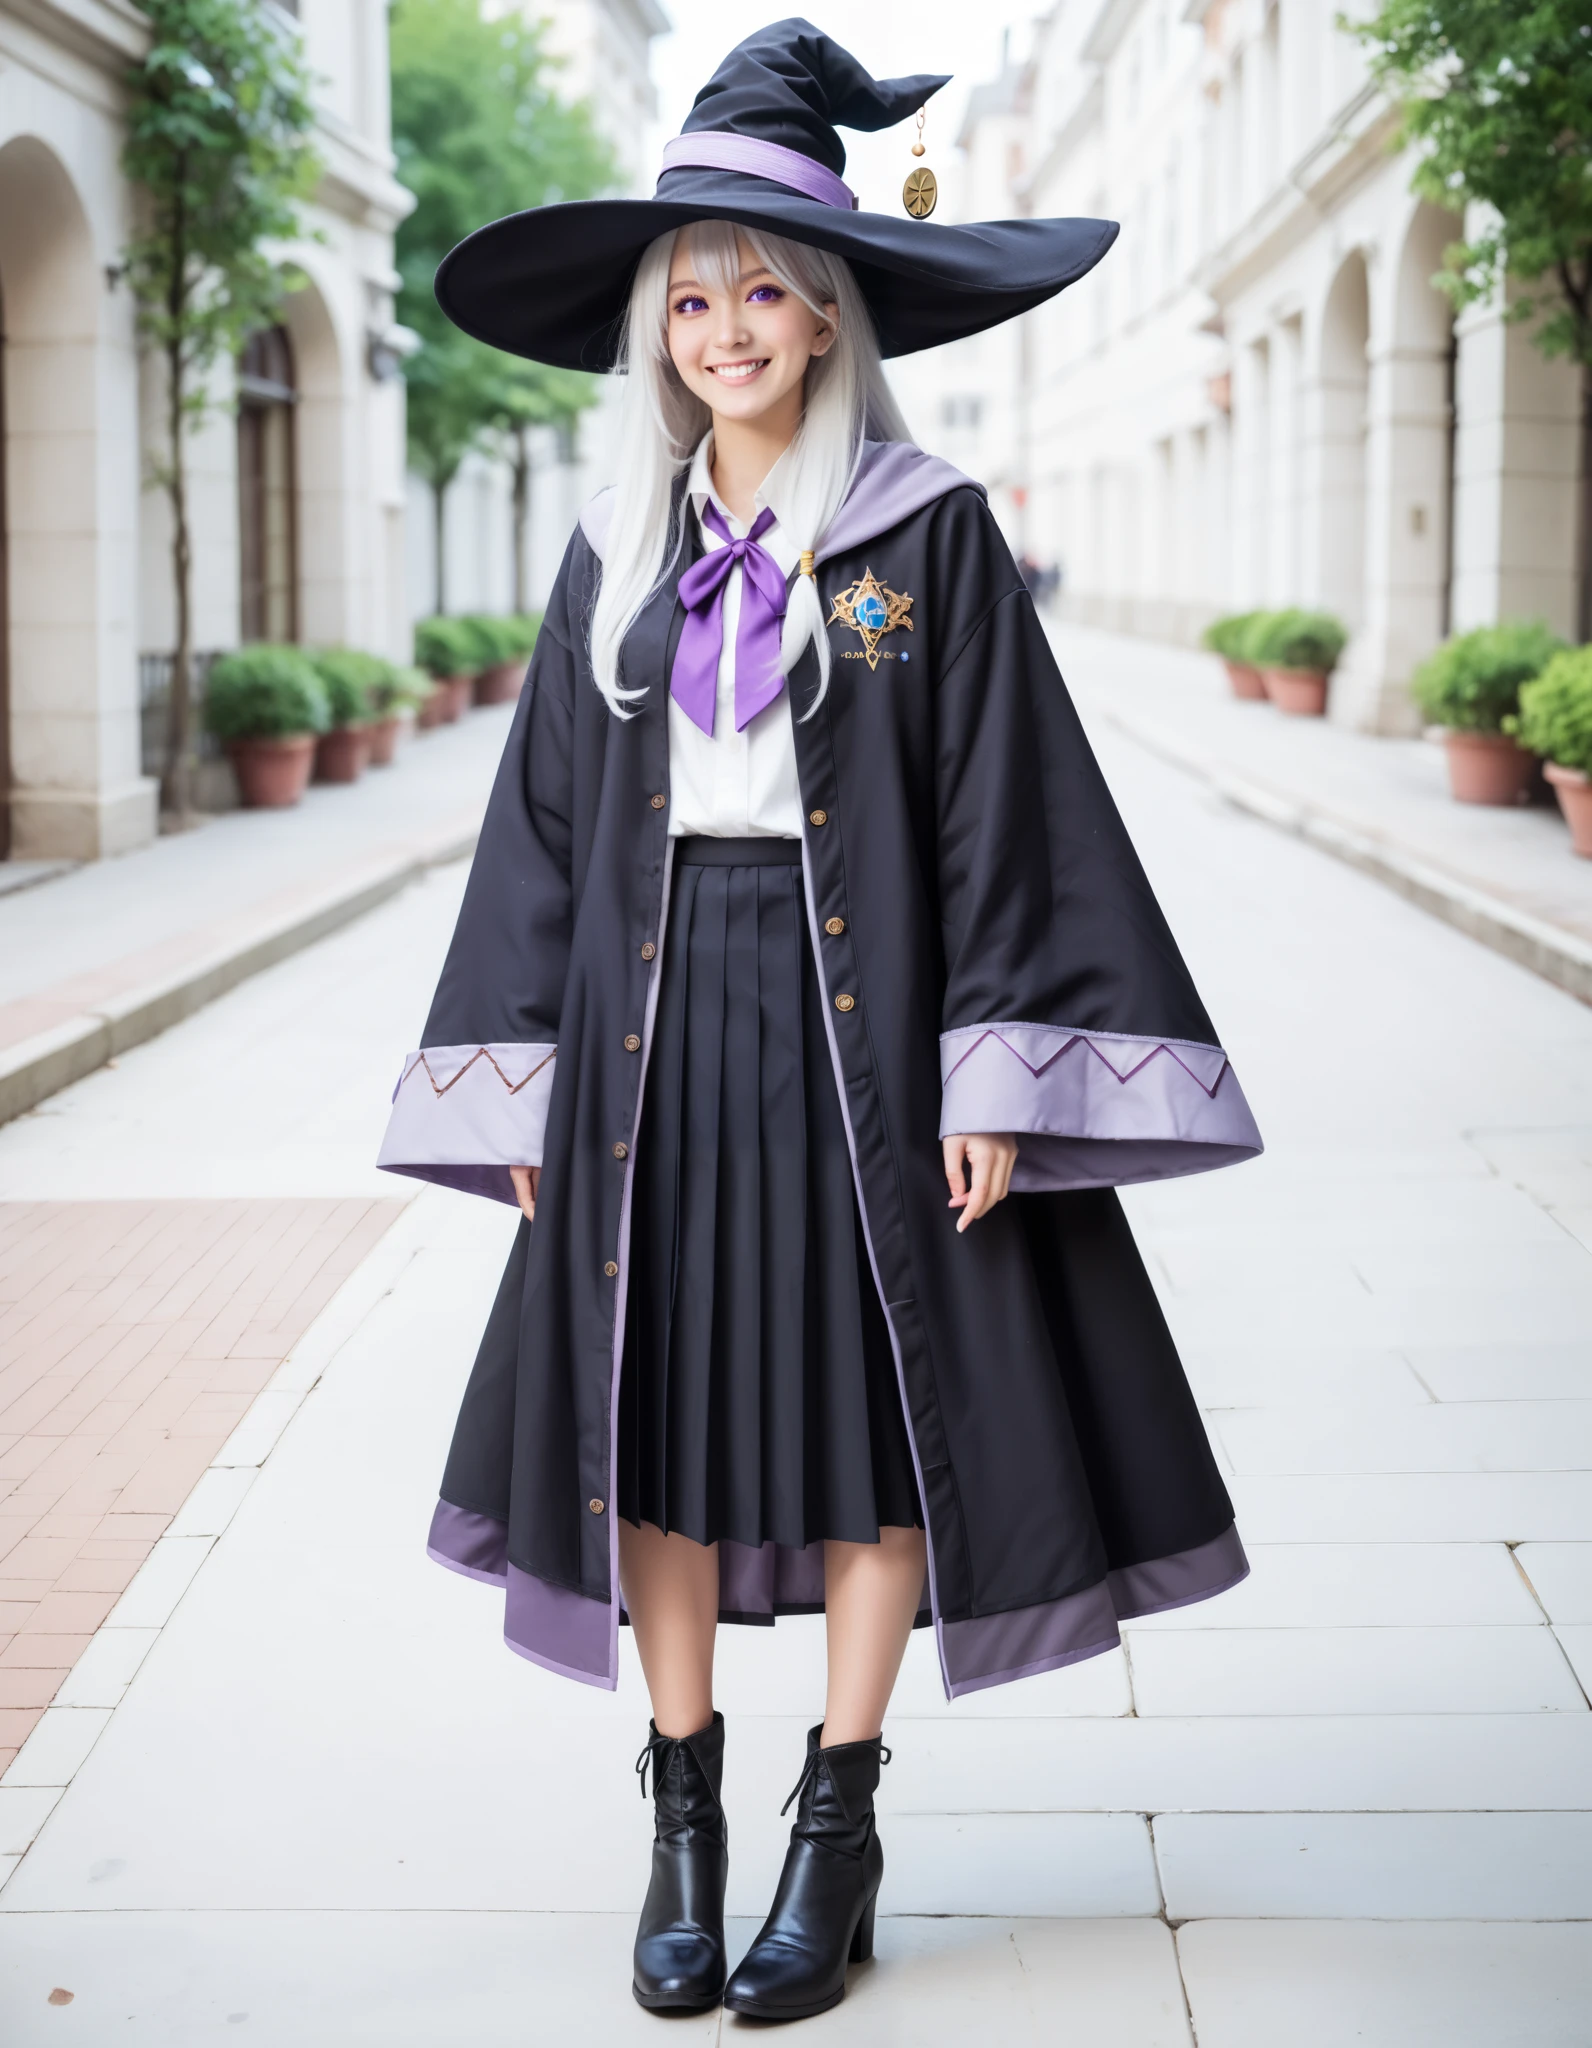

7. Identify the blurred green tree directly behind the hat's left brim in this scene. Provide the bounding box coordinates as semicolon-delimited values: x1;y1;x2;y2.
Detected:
391;0;615;610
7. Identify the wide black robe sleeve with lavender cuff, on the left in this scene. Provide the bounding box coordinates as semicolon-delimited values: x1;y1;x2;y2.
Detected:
377;541;582;1202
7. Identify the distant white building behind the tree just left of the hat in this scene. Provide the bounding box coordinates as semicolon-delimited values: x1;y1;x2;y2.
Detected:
408;0;670;618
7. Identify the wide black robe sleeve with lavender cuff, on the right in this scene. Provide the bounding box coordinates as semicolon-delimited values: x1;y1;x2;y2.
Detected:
934;508;1260;1192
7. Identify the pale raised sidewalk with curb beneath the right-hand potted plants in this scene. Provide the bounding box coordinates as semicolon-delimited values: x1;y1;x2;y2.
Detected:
1051;623;1592;1001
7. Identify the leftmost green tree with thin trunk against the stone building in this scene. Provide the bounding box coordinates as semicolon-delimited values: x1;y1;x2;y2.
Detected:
123;0;320;817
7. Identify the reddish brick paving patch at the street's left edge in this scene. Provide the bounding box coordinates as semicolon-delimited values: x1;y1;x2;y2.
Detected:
0;1196;404;1772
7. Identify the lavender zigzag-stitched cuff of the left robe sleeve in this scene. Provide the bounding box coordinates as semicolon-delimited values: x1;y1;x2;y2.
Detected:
377;1044;557;1202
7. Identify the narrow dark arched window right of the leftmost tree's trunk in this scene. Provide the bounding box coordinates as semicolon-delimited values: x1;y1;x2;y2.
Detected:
238;328;299;641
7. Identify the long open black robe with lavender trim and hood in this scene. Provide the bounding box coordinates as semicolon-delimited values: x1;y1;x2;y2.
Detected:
381;444;1260;1696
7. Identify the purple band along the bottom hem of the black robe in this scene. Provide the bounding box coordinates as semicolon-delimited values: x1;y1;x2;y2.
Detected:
426;1501;1250;1700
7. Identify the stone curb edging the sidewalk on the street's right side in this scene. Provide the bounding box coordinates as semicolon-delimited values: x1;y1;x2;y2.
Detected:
1086;698;1592;1004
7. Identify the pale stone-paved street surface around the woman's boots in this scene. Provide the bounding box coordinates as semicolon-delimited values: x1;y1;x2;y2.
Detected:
0;700;1592;2048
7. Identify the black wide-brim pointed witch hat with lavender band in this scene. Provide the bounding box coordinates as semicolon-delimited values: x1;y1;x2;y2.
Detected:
436;20;1117;371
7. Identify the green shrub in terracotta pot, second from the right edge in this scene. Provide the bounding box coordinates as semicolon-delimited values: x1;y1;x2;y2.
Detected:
1412;618;1563;803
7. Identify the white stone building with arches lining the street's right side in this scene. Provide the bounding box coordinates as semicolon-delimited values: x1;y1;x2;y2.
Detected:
938;0;1586;731
